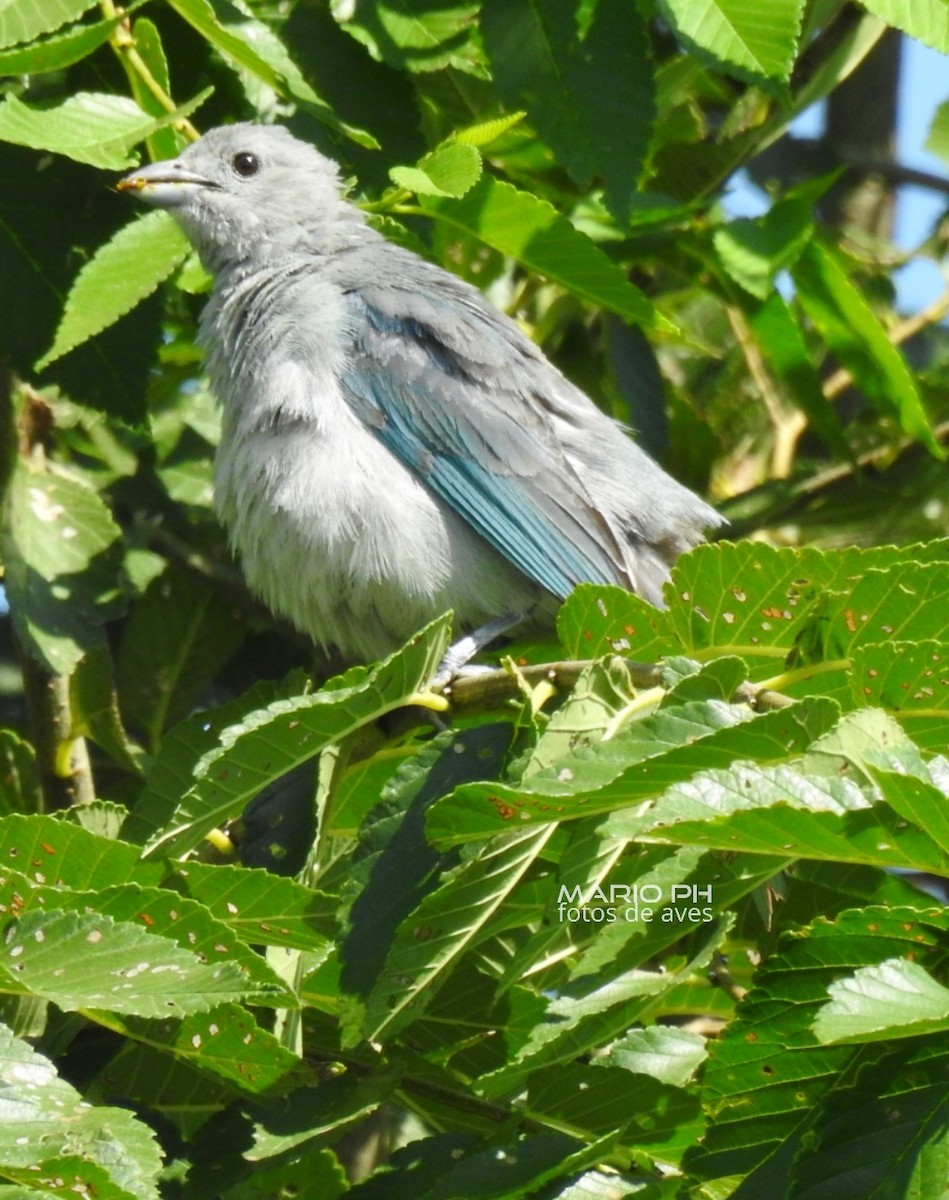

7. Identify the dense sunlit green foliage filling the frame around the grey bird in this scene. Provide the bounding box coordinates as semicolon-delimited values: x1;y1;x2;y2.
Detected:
0;0;949;1200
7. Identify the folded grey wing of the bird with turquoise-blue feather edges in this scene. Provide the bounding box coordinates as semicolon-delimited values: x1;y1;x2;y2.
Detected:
343;264;631;596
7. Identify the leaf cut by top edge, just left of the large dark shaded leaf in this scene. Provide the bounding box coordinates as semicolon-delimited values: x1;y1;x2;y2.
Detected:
330;0;482;73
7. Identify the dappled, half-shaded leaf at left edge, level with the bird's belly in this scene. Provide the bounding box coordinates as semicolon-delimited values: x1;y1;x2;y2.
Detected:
4;460;125;673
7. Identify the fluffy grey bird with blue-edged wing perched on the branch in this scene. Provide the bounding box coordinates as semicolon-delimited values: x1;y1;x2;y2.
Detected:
118;124;722;662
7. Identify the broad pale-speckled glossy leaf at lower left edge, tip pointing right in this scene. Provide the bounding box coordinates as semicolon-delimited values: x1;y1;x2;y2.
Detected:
0;910;254;1018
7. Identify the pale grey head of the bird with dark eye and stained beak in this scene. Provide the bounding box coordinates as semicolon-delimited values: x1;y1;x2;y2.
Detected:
118;125;361;271
